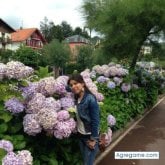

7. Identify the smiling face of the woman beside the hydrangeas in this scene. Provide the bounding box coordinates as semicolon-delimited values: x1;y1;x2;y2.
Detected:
69;80;84;94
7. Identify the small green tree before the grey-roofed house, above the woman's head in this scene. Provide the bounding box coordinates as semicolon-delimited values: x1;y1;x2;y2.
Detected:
77;45;93;71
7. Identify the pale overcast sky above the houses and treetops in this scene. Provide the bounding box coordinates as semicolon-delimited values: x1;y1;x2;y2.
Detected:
0;0;84;29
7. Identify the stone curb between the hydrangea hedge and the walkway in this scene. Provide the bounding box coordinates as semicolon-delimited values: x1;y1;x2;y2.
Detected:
94;94;165;165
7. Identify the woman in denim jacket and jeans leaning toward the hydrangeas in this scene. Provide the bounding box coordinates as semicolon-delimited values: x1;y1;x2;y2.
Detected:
68;74;100;165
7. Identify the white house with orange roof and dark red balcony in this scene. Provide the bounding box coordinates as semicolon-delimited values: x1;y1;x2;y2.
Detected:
11;28;46;50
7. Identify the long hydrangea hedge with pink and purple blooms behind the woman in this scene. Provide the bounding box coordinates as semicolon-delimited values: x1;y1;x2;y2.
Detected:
0;61;164;165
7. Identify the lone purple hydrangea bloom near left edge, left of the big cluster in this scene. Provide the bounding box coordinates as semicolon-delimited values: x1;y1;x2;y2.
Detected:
5;98;25;114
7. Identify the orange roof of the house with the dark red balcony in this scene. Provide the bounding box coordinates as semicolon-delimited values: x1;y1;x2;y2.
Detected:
11;28;46;43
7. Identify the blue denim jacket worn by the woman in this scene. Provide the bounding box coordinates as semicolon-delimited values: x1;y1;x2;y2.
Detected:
76;92;100;140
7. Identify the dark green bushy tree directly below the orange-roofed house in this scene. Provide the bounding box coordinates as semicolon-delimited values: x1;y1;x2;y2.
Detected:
13;45;40;68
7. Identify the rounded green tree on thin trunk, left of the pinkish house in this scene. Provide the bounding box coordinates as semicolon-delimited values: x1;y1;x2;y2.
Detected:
43;40;70;77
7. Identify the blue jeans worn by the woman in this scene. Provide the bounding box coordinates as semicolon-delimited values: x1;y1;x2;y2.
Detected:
79;136;99;165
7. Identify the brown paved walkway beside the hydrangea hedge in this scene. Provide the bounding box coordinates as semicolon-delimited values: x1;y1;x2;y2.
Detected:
96;98;165;165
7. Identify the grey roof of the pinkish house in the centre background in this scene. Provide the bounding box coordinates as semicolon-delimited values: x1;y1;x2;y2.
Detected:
66;35;90;44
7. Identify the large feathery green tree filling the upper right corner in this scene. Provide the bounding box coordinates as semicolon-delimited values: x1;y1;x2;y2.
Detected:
82;0;165;69
